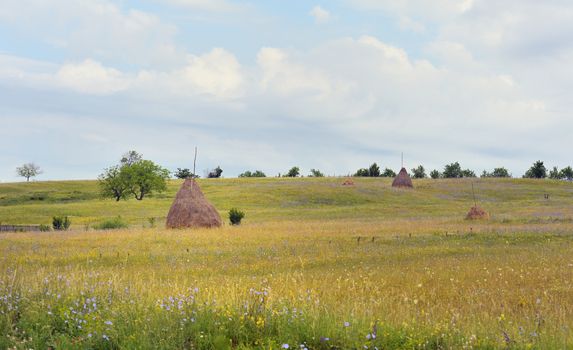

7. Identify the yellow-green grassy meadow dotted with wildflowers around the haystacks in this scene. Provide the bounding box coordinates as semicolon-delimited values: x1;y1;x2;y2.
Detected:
0;178;573;349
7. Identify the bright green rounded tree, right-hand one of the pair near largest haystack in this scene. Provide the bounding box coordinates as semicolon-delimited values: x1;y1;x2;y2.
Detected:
125;160;169;201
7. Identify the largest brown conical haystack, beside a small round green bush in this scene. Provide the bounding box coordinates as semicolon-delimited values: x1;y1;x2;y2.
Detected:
165;179;223;228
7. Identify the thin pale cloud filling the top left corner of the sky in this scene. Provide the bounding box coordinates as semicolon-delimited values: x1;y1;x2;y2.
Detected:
0;0;184;65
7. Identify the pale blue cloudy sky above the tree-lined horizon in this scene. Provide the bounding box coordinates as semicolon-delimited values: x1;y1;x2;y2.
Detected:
0;0;573;182
